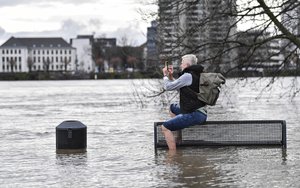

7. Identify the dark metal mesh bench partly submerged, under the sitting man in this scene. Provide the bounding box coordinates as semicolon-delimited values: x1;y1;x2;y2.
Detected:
154;120;286;151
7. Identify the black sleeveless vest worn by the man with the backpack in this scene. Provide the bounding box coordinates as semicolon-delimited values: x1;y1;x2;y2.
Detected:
179;65;205;114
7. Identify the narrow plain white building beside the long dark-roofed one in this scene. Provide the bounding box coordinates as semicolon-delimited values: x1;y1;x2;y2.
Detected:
71;35;95;73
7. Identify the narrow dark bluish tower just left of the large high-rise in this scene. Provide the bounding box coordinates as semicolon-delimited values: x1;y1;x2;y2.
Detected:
146;21;159;69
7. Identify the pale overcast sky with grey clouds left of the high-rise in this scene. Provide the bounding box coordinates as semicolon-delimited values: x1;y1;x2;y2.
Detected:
0;0;157;45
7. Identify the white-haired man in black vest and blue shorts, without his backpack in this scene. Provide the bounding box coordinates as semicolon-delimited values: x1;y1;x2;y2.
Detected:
161;54;207;150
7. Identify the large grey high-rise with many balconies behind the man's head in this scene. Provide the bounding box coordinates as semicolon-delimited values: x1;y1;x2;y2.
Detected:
158;0;237;69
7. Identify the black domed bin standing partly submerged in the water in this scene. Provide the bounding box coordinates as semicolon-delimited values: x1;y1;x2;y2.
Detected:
56;120;87;154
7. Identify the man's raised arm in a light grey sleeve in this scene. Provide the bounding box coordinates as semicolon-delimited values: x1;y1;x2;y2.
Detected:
164;73;193;91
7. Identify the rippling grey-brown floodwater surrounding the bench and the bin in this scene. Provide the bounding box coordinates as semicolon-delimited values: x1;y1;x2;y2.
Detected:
0;78;300;188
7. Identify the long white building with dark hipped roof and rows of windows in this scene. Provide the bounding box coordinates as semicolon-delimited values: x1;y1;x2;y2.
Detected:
0;37;76;72
